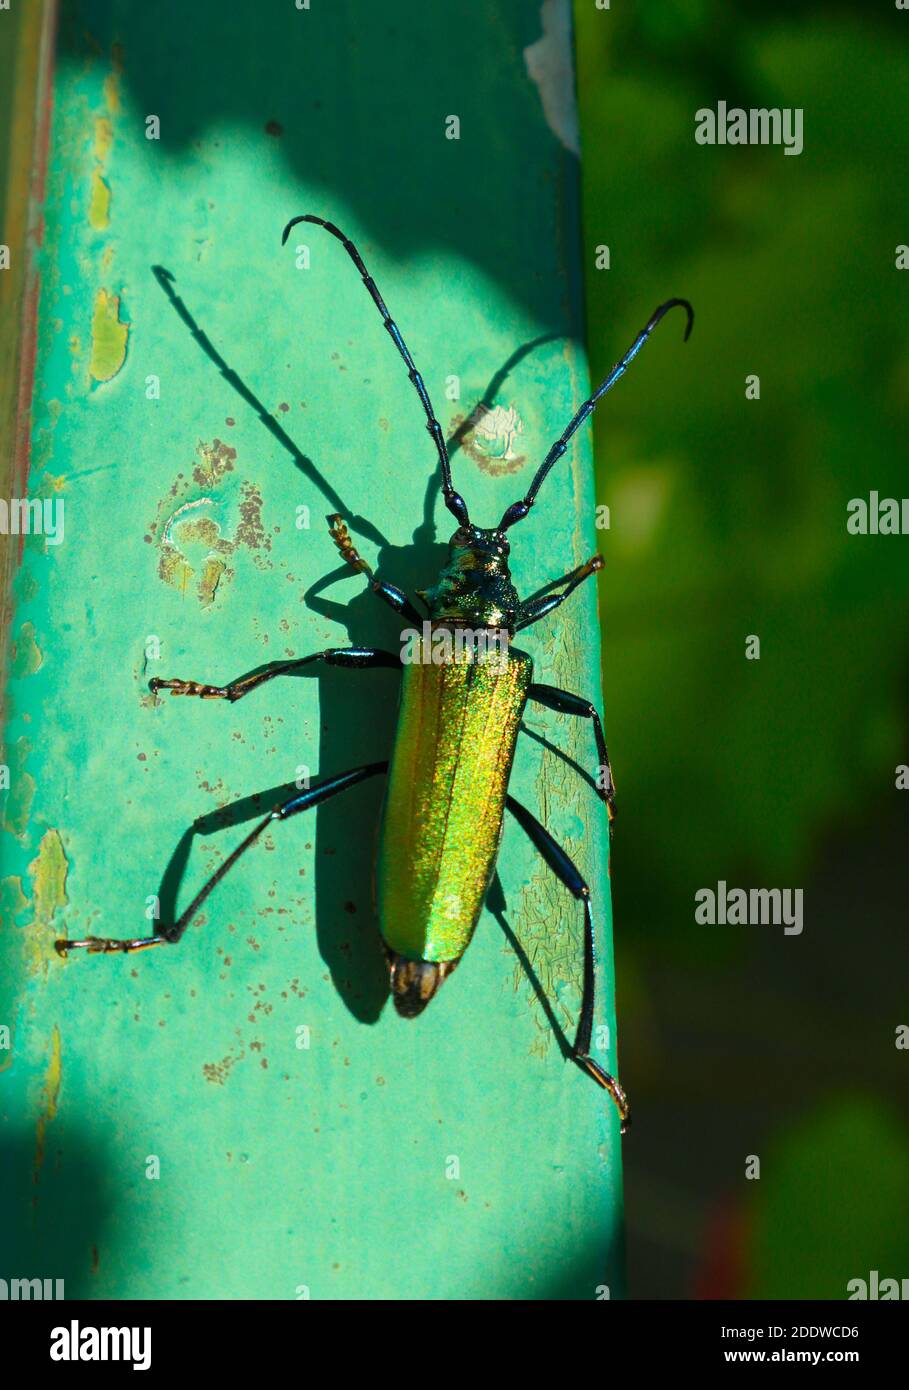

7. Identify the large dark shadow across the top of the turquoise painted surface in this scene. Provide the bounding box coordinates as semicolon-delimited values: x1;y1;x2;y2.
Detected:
57;0;578;332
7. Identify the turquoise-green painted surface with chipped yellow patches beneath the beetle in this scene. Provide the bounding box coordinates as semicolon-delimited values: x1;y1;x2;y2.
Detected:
0;0;621;1298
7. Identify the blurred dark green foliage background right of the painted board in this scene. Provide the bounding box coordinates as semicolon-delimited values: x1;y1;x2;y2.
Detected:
575;0;909;1298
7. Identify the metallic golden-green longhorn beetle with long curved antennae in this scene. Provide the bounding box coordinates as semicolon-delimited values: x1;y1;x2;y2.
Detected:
56;213;694;1133
